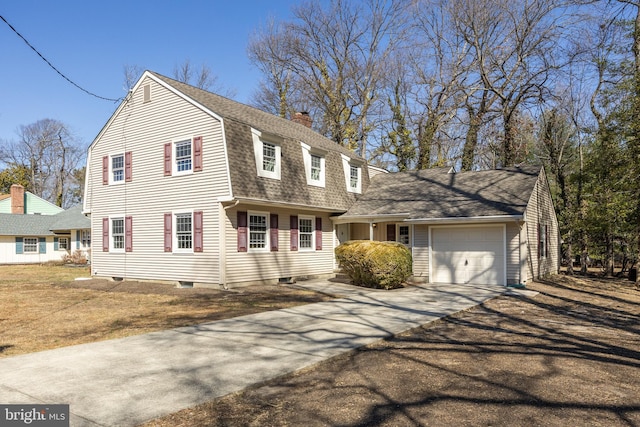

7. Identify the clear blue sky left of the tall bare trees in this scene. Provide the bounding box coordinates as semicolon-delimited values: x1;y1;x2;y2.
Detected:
0;0;297;147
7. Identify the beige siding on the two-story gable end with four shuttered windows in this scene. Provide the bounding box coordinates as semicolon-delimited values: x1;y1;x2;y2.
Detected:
87;79;229;283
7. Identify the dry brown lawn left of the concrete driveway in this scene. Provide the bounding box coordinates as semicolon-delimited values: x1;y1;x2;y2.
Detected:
0;264;330;357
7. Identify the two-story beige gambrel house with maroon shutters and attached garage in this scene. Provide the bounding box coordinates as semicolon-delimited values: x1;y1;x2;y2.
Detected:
84;71;558;286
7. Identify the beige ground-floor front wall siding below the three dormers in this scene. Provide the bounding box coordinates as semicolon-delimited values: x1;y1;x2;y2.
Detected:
225;205;334;286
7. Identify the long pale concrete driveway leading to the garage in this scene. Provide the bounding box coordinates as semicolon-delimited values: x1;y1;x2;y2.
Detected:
0;280;506;426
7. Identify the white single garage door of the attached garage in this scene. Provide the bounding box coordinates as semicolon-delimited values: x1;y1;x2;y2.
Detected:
431;225;506;285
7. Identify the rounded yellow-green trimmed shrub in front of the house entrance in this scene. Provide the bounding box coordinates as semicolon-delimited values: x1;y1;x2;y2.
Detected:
335;240;412;289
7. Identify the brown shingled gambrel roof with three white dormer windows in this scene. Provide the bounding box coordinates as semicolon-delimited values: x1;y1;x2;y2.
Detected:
150;72;369;212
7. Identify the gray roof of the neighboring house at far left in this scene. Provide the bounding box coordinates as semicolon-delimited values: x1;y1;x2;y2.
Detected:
0;206;91;236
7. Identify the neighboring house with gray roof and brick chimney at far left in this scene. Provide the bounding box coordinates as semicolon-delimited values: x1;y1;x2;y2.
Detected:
0;185;91;264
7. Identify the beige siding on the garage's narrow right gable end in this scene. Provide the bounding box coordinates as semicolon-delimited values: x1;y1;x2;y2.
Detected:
525;173;560;280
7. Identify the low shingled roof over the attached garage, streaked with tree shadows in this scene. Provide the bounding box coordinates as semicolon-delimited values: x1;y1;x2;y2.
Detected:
343;166;541;220
